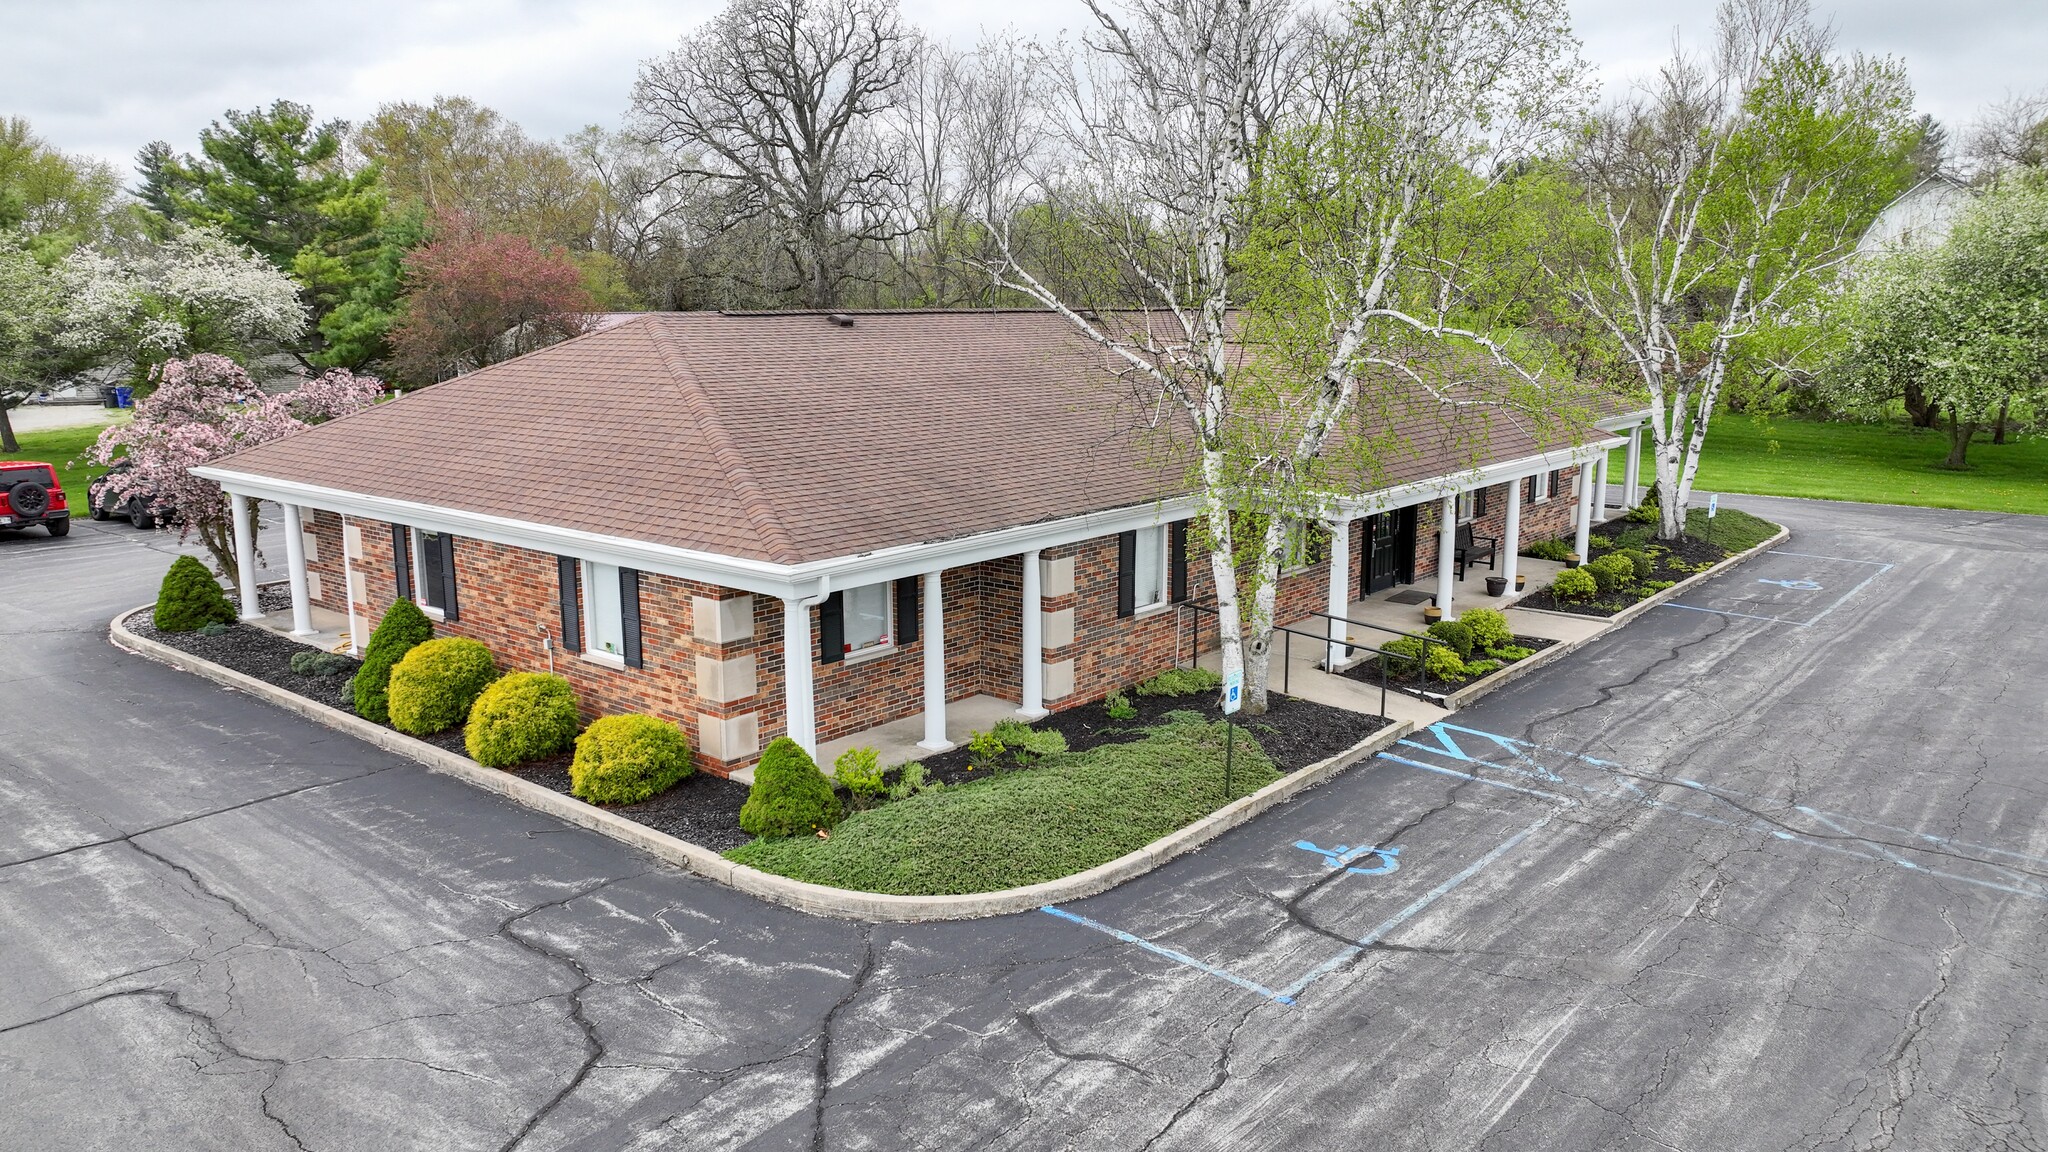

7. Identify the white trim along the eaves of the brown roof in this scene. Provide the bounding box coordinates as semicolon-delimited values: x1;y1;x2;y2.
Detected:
193;414;1642;599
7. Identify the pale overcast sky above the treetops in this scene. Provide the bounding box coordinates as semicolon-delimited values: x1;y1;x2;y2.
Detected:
0;0;2048;170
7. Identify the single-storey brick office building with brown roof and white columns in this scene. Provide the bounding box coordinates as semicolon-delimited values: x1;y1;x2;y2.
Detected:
201;312;1645;775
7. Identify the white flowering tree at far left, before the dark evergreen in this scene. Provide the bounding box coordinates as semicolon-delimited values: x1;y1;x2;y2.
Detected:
59;225;307;383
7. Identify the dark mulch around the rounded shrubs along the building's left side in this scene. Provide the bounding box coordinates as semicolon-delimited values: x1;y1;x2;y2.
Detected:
127;610;754;853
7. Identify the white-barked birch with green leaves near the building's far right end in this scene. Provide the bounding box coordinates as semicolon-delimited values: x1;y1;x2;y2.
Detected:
1563;0;1917;539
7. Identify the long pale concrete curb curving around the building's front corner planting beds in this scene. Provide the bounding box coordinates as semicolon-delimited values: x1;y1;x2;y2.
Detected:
109;605;1415;922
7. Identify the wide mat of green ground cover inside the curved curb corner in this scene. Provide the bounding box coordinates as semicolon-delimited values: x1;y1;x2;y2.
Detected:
727;713;1280;896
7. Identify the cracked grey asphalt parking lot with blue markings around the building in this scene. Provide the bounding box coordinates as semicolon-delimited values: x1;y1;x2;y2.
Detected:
0;498;2048;1152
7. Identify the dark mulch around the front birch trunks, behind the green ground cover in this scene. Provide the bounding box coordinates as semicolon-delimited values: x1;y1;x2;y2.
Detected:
924;680;1391;783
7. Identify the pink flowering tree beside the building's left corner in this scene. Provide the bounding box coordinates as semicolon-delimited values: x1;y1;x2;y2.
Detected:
88;355;383;584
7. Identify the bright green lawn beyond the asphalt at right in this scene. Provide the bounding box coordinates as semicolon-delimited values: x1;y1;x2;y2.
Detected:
1608;412;2048;515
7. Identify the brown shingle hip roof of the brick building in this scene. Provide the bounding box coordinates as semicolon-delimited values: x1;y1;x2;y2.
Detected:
219;312;1630;564
